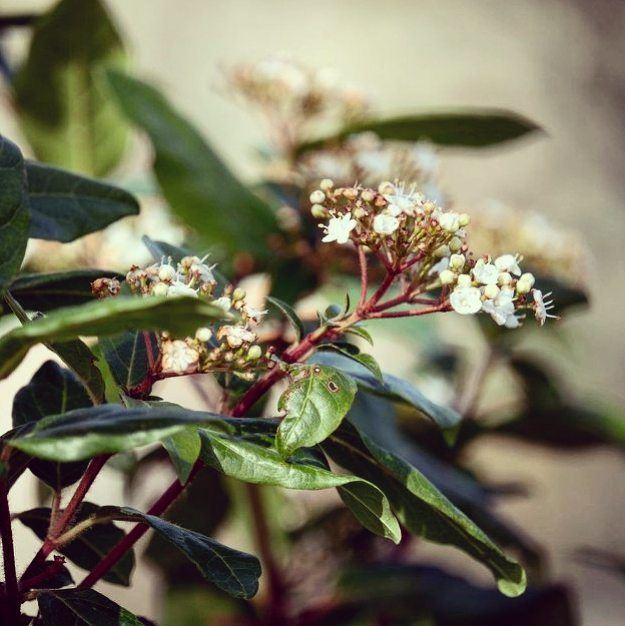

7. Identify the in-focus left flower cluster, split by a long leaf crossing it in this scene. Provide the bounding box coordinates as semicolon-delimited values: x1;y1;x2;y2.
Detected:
92;256;267;380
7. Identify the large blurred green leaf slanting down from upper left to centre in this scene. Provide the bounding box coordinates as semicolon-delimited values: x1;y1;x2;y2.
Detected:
107;71;277;259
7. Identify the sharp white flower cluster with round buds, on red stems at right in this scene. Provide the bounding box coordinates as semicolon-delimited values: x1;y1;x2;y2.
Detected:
310;179;555;328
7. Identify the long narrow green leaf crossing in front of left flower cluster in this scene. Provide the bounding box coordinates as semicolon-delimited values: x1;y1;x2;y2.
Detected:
0;296;224;380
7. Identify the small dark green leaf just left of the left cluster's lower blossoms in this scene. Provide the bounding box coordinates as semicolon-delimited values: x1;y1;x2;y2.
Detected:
99;330;158;391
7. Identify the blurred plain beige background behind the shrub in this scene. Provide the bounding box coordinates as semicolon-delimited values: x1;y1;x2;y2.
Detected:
0;0;625;626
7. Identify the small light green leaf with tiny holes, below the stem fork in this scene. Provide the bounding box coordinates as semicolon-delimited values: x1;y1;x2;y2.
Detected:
276;365;356;457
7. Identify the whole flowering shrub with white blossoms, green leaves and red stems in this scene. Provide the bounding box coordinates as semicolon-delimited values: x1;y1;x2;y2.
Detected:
0;0;613;626
